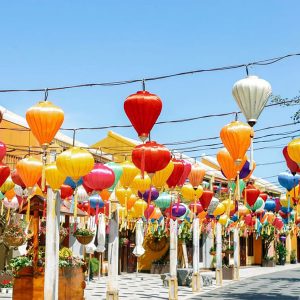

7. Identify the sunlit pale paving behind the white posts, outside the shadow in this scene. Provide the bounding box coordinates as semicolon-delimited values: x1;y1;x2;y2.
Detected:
85;264;300;300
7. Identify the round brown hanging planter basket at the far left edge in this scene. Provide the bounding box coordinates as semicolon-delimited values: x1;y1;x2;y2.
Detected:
3;223;26;247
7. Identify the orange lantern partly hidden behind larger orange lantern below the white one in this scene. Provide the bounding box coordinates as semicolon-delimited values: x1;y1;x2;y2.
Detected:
217;148;247;180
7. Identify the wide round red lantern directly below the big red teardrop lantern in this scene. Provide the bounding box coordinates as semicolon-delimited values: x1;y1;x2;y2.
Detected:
132;141;171;175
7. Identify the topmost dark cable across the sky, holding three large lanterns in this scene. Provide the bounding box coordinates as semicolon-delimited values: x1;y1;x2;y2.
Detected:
0;53;300;94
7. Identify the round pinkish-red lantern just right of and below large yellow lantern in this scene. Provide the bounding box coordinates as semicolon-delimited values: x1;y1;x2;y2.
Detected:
83;163;115;191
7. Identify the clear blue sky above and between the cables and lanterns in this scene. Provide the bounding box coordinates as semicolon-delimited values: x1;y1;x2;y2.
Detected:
0;0;300;185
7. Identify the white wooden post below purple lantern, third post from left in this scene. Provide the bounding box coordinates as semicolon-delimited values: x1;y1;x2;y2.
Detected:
169;219;178;300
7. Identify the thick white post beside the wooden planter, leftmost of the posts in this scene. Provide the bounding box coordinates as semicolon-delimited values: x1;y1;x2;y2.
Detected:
44;188;60;300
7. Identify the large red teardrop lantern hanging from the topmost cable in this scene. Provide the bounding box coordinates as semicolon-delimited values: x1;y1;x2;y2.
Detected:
124;91;162;142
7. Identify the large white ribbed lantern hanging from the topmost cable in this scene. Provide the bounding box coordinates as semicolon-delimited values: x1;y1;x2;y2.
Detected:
232;76;272;127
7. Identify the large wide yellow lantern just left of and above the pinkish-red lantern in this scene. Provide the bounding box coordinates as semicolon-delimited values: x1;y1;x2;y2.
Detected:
56;147;94;181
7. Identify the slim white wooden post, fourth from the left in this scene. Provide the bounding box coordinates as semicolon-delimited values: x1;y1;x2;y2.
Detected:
192;218;201;292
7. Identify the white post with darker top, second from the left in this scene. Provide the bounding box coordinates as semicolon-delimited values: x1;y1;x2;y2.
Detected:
106;210;119;300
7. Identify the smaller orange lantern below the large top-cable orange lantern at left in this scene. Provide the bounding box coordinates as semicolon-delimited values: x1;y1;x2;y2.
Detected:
16;157;43;188
